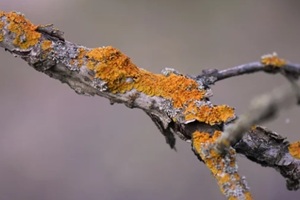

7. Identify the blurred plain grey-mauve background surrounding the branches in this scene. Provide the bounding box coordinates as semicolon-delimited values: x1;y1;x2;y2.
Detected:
0;0;300;200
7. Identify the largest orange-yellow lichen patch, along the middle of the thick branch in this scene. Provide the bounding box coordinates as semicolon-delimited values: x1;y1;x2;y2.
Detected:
76;46;234;125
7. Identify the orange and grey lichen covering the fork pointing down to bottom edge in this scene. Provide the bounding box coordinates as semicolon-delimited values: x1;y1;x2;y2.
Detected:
192;131;252;200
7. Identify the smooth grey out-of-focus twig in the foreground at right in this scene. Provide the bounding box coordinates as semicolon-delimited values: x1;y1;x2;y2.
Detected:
216;80;299;153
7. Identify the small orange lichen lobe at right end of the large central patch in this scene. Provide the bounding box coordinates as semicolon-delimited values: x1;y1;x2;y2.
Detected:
185;103;234;125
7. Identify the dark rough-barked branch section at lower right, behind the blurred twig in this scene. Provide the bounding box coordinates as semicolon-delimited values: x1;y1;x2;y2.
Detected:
233;126;300;190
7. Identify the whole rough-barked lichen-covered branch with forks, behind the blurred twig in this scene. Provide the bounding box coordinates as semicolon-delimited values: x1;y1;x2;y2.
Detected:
0;12;300;199
